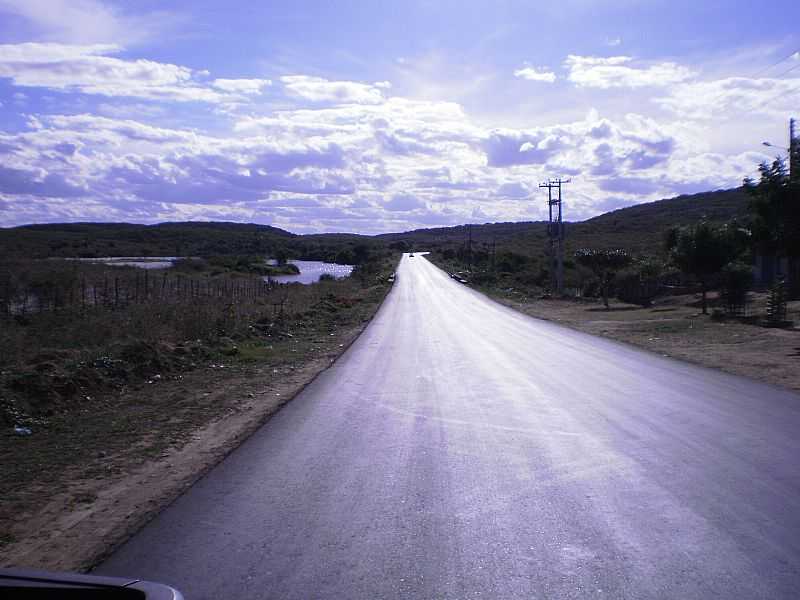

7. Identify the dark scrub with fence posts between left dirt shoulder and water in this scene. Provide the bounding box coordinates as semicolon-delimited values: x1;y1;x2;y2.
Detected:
0;246;393;425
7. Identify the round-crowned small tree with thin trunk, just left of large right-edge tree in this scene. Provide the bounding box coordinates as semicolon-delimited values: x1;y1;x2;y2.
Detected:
667;221;746;315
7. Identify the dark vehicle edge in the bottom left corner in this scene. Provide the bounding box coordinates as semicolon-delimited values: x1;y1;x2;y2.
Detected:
0;569;183;600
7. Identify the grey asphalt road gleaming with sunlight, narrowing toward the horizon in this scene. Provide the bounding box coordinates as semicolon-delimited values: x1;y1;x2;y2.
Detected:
99;256;800;600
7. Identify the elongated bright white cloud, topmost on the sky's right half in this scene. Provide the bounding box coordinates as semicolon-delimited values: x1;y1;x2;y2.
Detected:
564;54;694;89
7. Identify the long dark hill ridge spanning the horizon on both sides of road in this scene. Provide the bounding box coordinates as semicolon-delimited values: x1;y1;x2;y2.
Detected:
0;188;747;260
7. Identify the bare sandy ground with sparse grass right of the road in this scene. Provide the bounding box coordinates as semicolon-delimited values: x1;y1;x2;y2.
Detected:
429;255;800;392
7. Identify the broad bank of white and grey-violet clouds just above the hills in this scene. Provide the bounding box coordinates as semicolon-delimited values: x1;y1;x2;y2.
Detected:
0;56;768;233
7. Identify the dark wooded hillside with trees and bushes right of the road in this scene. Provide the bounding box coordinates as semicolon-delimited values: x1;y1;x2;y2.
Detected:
422;155;800;325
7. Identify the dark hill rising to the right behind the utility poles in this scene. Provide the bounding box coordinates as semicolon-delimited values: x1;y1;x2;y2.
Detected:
378;188;748;256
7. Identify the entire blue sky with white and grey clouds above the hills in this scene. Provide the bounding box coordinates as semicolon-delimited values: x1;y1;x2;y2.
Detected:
0;0;800;233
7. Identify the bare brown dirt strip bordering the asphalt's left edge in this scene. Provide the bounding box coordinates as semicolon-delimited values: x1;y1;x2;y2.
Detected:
0;323;366;571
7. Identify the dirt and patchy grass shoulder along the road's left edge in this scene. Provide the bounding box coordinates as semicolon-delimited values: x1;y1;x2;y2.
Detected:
0;282;394;571
